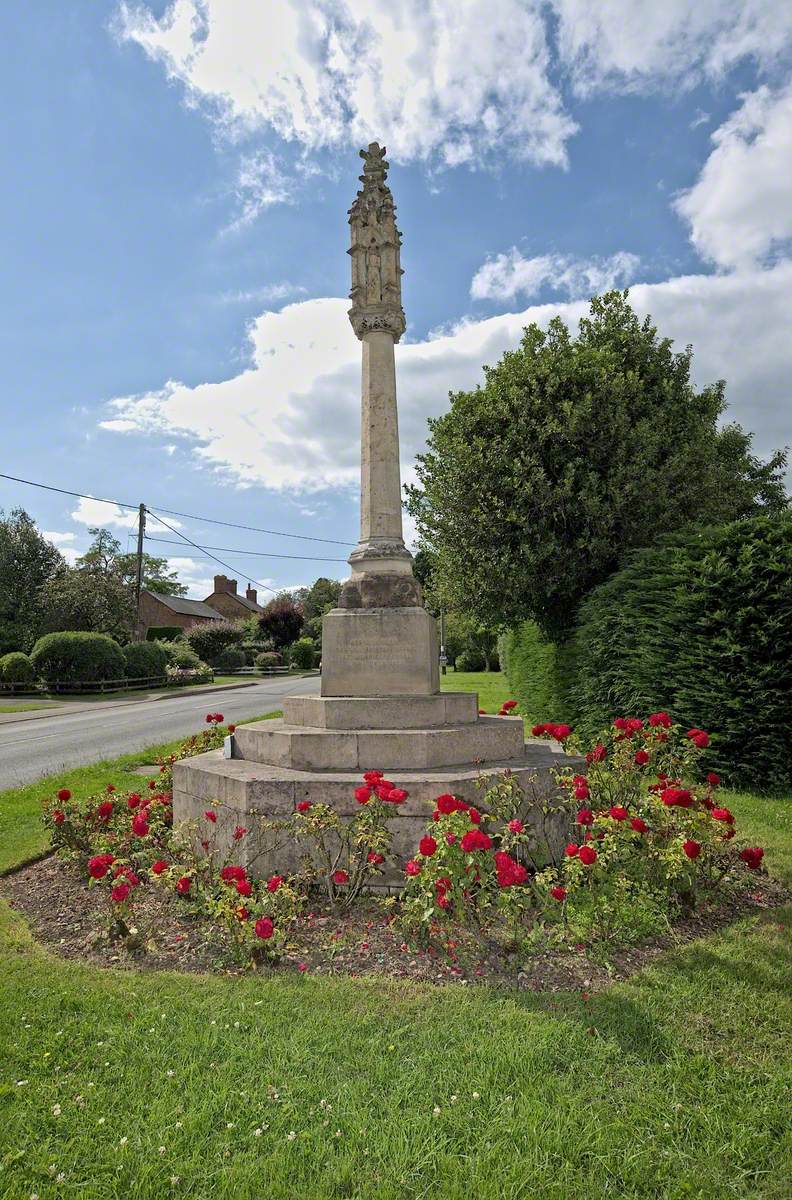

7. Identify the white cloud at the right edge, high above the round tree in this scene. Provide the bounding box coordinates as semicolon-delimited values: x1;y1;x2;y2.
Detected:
674;84;792;269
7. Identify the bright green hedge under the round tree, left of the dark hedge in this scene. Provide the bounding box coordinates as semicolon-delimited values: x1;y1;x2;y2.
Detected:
498;620;580;725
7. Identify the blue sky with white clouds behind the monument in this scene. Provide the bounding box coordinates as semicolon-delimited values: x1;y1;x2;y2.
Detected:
0;0;792;595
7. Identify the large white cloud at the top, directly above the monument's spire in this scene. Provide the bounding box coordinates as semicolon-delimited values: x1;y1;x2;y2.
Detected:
119;0;576;166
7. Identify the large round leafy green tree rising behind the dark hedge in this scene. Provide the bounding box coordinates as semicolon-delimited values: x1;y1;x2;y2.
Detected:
408;292;787;637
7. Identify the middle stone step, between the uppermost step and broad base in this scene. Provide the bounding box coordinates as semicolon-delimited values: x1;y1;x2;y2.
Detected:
232;716;524;772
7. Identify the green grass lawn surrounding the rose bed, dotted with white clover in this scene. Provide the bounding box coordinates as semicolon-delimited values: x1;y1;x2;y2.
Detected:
0;676;792;1200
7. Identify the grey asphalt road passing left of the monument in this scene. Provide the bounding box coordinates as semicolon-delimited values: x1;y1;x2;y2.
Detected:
0;677;319;791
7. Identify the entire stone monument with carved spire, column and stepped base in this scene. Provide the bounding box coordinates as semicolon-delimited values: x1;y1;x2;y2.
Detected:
173;143;580;886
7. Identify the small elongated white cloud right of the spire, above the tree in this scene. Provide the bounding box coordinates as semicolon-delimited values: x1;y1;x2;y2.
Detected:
470;246;641;300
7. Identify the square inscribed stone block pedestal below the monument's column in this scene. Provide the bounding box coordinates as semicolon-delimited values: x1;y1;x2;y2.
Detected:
322;608;440;696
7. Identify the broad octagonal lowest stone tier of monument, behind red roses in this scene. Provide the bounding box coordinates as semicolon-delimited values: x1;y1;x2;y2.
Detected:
173;742;582;888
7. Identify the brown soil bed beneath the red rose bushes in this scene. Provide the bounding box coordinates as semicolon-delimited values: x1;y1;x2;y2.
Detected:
0;857;790;992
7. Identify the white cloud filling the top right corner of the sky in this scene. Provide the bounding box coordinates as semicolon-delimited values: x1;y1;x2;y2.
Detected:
551;0;792;94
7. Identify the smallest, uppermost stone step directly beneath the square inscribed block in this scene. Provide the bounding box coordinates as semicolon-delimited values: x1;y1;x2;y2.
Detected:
283;691;479;730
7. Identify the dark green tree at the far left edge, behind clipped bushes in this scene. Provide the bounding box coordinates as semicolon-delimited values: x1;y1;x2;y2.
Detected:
0;509;66;654
